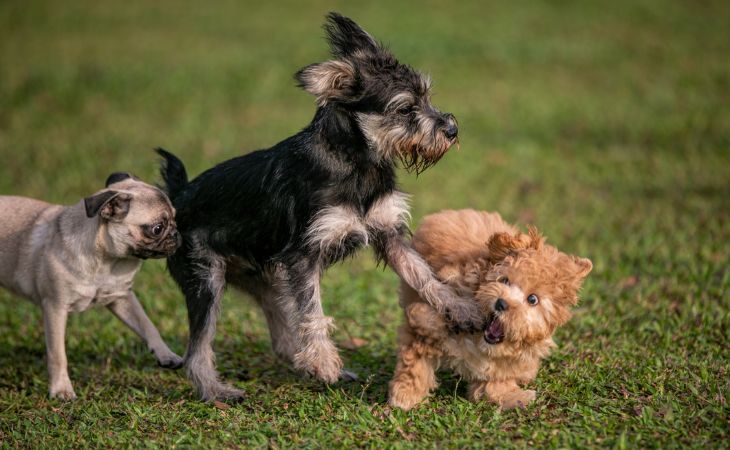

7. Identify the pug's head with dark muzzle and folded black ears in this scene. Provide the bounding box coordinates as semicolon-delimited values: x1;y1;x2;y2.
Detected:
84;172;182;259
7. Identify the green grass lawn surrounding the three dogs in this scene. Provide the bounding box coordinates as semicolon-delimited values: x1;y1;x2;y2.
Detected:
0;0;730;448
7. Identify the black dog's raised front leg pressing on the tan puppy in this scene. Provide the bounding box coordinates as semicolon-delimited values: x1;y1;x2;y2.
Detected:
375;230;484;332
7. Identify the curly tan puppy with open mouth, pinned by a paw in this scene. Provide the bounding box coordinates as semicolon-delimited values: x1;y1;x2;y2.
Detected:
389;210;592;410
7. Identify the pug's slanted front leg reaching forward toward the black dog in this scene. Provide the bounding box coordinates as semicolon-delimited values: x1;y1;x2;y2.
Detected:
107;291;183;369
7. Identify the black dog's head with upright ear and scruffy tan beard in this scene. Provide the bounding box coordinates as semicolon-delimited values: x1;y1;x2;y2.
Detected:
296;13;458;172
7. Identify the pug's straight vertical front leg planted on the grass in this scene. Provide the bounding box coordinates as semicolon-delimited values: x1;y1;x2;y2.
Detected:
43;301;76;400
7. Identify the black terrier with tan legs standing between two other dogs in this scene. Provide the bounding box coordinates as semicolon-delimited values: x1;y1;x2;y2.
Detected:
158;13;482;400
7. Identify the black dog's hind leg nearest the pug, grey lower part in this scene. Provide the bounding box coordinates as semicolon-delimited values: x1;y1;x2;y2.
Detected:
168;249;244;401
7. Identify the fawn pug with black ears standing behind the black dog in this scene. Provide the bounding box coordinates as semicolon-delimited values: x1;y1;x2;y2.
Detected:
0;173;182;400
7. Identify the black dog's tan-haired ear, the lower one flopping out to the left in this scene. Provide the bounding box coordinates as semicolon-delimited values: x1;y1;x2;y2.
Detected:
295;60;357;106
